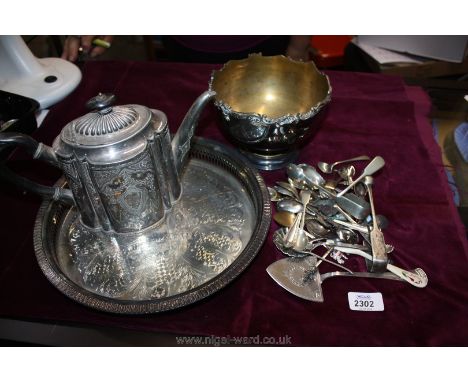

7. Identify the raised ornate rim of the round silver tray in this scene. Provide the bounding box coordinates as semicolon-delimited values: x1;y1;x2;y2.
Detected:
33;137;271;314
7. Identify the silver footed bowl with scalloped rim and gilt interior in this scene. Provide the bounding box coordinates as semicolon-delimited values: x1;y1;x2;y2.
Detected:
209;54;332;170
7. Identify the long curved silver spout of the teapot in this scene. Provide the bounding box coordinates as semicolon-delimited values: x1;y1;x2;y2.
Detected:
172;90;216;175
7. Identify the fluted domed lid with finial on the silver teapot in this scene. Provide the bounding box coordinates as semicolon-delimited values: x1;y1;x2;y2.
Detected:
61;93;160;146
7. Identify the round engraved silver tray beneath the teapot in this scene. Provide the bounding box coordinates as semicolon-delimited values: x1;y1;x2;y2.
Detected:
34;138;271;314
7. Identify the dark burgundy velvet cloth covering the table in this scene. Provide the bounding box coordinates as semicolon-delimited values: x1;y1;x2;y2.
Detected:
0;62;468;346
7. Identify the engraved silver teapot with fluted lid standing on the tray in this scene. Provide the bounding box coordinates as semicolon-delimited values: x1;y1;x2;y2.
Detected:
0;91;215;233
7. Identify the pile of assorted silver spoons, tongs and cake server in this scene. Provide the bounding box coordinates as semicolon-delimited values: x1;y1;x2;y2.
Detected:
267;156;428;302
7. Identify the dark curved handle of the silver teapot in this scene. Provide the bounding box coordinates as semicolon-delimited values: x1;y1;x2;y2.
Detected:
0;133;75;205
